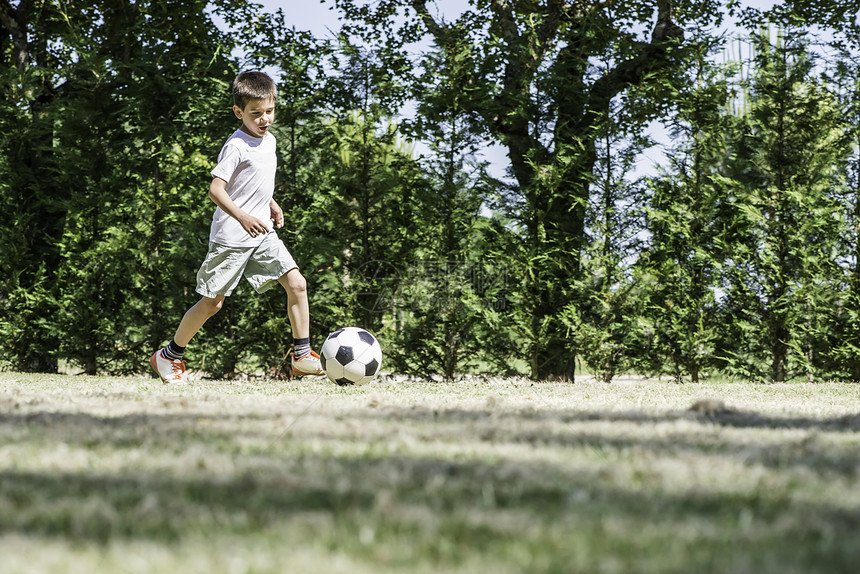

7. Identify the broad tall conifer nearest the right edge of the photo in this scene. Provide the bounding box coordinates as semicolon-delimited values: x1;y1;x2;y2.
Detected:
723;30;846;381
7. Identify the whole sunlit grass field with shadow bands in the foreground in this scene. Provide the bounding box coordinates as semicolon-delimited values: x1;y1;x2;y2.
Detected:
0;373;860;574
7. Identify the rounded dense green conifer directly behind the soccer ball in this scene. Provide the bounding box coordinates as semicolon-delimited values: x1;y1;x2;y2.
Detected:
299;106;426;368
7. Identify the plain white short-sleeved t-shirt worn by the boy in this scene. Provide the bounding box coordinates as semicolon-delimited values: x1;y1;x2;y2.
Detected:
209;129;277;247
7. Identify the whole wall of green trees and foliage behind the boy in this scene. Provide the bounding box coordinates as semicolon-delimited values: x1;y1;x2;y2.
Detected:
5;0;860;381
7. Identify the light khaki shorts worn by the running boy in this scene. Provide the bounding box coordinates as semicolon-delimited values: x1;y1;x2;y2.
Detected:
197;233;298;298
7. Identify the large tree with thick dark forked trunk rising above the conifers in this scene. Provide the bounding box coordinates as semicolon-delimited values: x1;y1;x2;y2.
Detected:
338;0;719;378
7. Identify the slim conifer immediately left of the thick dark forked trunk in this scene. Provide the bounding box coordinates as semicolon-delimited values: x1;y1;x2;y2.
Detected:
382;27;507;381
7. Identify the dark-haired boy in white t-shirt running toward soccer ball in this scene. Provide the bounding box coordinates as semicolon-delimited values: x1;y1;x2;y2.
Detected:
149;72;323;383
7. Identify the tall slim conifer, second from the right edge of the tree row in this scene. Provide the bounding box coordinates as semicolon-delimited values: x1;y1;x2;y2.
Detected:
637;34;733;383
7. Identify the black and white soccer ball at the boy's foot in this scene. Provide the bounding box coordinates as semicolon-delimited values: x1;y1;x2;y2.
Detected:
320;327;382;387
